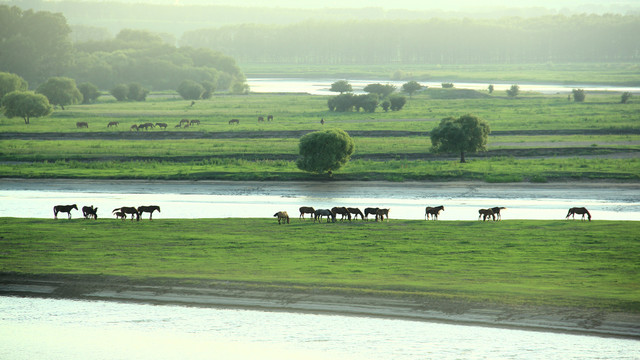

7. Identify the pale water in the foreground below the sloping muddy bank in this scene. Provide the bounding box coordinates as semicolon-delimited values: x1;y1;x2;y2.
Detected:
0;297;640;360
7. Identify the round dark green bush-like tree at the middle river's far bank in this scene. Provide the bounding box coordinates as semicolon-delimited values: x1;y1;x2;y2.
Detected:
296;129;355;175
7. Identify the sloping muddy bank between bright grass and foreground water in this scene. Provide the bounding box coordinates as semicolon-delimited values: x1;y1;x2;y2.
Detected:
0;273;640;340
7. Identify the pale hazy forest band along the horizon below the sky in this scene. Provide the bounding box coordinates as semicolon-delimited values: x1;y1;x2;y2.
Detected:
180;15;640;64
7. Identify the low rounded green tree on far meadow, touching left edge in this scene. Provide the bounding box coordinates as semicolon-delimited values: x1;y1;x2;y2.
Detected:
2;91;52;124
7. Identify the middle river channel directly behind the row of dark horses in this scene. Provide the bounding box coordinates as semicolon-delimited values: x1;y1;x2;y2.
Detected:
0;179;640;221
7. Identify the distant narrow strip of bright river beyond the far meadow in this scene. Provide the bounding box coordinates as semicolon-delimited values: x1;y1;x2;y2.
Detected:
247;78;640;95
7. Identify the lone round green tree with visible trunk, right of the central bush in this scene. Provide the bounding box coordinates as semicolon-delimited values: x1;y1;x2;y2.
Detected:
430;114;491;163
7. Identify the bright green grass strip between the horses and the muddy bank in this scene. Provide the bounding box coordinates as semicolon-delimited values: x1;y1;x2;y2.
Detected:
0;218;640;312
